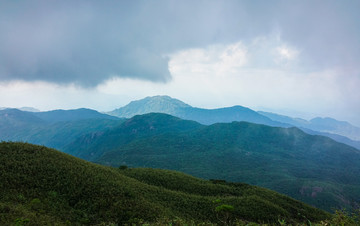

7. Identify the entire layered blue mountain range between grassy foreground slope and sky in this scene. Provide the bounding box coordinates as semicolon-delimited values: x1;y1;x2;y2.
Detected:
0;96;360;211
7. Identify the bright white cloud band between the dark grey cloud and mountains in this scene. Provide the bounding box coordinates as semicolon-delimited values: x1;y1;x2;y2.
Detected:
0;36;360;127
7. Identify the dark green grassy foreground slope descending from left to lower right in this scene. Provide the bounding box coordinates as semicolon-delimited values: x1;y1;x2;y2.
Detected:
0;142;329;225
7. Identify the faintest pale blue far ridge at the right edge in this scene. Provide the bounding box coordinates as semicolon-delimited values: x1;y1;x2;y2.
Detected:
258;111;360;142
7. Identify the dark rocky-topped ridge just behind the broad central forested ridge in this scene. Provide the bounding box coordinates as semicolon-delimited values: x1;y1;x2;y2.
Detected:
62;113;204;161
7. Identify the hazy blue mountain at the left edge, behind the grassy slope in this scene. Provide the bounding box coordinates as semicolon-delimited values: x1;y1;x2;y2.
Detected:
0;109;122;149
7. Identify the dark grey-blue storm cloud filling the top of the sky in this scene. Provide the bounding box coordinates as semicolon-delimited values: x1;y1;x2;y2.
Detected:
0;0;360;87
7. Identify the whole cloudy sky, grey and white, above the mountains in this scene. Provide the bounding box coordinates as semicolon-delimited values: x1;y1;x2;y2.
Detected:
0;0;360;126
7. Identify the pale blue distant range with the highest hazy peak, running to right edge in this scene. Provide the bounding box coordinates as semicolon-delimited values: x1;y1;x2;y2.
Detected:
107;96;360;149
